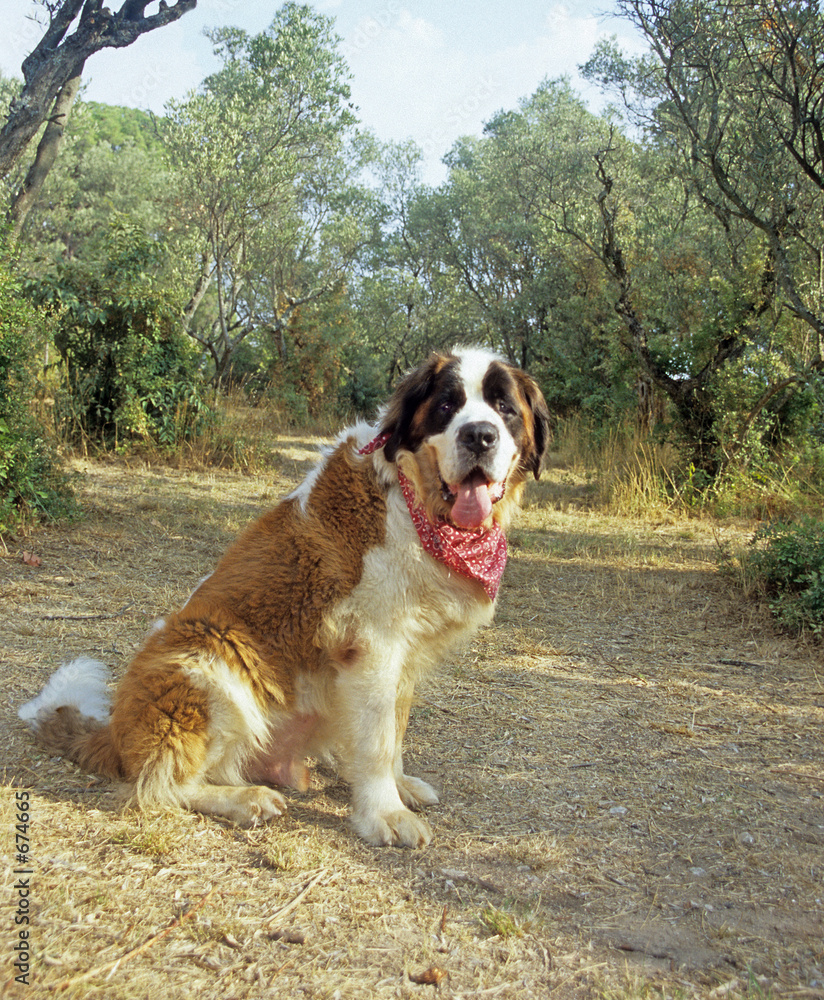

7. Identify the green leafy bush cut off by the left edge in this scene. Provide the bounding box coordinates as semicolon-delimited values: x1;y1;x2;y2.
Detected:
0;241;75;534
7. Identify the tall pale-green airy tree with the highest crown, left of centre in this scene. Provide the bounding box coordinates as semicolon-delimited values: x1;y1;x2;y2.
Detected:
164;3;362;383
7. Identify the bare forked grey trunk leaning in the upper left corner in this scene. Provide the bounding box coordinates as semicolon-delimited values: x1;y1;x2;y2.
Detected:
0;0;197;233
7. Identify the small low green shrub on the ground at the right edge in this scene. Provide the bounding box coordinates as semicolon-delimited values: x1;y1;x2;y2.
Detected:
749;517;824;634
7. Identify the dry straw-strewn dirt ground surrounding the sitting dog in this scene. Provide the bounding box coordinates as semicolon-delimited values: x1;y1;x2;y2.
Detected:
0;439;824;1000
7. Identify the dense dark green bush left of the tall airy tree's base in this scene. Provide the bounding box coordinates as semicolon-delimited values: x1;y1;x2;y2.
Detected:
29;219;206;454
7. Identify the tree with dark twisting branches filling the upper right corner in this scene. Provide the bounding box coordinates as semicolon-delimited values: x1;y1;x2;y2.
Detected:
585;0;824;466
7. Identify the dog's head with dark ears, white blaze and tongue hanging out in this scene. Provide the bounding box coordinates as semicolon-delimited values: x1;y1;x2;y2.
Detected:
381;348;550;529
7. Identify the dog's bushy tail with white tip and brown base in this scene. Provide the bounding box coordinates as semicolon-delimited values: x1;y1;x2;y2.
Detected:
17;657;123;779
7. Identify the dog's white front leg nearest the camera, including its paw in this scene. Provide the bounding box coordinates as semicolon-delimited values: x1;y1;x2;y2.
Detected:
337;654;432;847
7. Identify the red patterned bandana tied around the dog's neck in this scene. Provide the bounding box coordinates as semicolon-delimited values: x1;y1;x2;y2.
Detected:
358;433;507;601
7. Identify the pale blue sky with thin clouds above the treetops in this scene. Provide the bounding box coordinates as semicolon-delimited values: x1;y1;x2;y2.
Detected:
0;0;643;185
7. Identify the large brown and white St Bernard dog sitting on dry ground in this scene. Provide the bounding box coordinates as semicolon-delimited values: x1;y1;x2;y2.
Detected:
20;348;549;847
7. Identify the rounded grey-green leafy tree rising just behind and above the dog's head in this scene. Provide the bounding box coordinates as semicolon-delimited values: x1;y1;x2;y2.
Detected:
428;81;627;419
